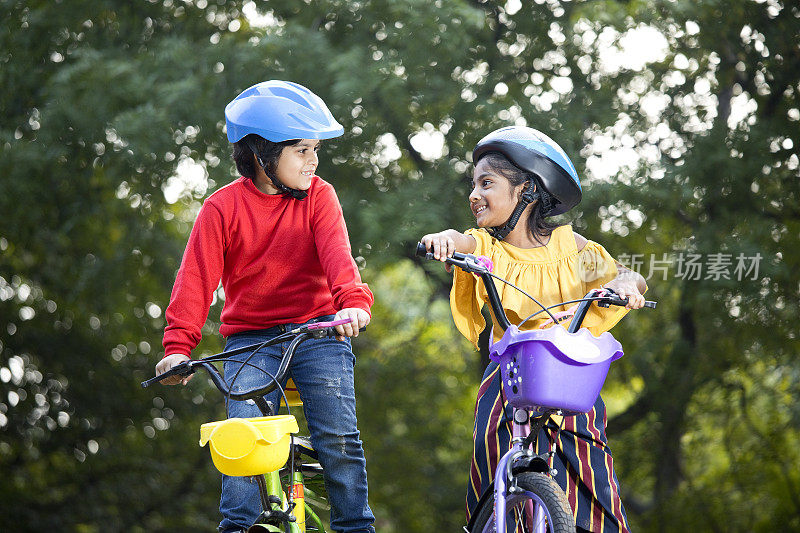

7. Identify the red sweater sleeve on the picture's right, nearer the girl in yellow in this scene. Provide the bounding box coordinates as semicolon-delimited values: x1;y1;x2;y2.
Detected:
313;183;374;313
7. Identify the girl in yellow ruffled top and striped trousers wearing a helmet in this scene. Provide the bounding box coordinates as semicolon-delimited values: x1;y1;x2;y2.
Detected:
421;126;646;532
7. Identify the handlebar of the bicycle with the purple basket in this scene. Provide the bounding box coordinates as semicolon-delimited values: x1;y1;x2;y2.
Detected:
416;242;657;333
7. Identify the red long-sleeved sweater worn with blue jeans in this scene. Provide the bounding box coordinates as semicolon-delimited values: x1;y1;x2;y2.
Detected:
164;176;373;355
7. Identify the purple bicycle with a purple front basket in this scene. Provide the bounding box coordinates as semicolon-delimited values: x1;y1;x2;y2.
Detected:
416;243;656;533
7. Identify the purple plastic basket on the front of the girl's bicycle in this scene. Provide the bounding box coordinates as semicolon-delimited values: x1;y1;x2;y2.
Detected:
489;325;622;414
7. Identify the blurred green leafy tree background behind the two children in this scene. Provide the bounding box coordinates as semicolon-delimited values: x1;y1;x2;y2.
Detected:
0;0;800;533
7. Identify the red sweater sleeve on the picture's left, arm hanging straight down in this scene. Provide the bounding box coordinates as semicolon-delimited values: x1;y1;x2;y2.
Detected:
164;202;225;357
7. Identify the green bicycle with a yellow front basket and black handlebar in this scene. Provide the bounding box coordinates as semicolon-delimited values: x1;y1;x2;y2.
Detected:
142;319;356;533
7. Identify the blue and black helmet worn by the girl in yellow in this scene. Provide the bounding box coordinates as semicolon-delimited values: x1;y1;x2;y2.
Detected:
472;126;582;216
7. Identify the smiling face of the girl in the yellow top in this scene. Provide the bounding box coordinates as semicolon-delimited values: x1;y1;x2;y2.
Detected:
469;158;525;228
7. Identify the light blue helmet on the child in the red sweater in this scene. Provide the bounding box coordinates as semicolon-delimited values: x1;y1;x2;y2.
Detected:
225;80;344;143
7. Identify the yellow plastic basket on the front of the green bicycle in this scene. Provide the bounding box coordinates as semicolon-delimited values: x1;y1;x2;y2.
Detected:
200;415;299;476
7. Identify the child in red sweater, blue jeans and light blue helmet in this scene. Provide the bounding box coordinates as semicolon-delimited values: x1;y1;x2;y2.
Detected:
161;81;375;533
